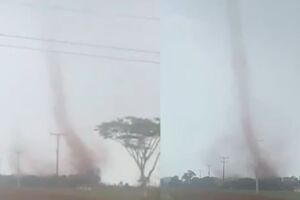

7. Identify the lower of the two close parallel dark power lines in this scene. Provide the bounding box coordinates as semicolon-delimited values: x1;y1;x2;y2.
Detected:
0;44;160;64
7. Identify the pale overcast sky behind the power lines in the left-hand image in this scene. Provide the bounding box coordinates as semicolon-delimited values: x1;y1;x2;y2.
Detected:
0;0;160;183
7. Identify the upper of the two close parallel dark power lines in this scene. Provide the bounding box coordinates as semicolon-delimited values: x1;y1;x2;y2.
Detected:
0;33;160;55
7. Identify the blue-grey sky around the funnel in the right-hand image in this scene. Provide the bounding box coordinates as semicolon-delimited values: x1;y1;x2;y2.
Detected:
161;0;300;176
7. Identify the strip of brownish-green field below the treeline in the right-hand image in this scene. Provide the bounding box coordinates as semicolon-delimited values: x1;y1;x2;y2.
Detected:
162;189;300;200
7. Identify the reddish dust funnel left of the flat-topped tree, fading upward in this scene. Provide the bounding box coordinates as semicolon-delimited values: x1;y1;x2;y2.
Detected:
47;54;97;173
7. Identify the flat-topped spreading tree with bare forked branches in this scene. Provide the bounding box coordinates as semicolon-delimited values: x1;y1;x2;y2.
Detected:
97;117;160;186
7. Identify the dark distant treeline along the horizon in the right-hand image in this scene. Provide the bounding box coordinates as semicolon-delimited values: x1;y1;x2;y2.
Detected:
161;170;300;191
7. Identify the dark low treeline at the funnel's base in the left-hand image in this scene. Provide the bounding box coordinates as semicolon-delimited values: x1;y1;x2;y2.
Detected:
0;175;100;187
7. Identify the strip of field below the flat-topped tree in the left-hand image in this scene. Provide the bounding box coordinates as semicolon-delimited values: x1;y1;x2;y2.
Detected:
0;187;160;200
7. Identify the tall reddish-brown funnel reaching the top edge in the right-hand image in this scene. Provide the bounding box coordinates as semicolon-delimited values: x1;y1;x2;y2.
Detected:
228;0;277;178
